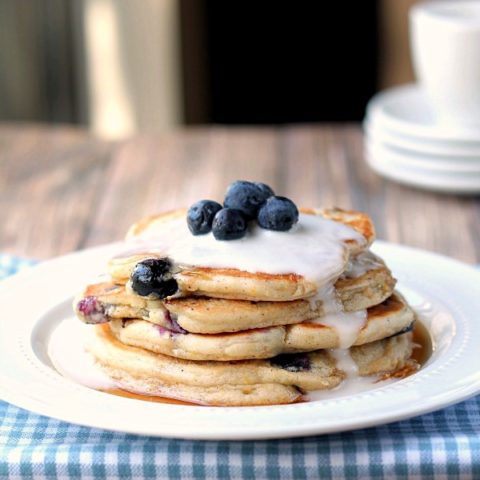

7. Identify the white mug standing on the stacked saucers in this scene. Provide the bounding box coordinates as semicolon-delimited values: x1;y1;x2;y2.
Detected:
410;0;480;129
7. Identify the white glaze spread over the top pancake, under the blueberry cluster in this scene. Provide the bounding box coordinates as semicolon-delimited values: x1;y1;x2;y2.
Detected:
120;214;366;286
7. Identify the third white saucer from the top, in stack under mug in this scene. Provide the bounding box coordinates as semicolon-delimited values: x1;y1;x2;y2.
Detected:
365;135;480;177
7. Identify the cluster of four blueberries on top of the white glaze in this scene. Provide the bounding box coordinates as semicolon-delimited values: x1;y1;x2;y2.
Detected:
187;180;298;240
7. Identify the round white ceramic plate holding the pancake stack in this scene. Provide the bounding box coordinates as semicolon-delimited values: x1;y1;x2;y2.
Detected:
0;241;480;439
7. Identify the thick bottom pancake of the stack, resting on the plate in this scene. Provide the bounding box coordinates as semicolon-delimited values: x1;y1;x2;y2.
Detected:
87;325;412;406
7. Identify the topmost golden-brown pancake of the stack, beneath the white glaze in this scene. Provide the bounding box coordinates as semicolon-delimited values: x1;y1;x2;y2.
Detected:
108;209;375;301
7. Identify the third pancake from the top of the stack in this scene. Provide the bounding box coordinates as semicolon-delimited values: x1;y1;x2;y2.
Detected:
110;293;415;361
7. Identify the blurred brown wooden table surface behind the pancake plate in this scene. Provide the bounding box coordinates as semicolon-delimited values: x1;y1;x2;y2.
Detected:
0;124;480;263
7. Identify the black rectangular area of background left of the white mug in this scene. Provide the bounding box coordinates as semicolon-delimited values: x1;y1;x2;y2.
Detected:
181;0;378;124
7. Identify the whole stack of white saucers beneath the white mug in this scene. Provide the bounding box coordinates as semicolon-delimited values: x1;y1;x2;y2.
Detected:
364;85;480;194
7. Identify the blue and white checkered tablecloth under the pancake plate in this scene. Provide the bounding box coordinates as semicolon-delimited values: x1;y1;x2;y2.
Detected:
0;255;480;480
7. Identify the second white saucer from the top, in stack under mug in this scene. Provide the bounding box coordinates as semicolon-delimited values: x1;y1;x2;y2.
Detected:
363;118;480;158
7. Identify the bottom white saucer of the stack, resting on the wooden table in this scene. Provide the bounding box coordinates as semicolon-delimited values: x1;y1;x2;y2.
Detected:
365;146;480;194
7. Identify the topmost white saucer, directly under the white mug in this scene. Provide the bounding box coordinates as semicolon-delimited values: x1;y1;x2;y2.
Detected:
367;84;480;142
